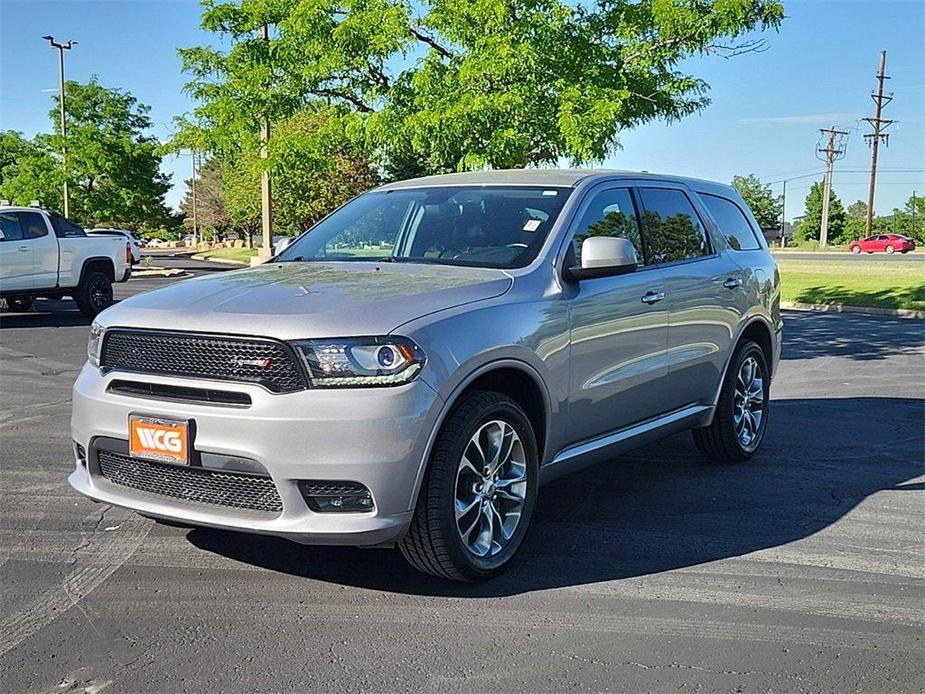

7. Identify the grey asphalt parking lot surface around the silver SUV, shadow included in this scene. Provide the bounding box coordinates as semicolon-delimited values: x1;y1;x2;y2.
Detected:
0;261;925;693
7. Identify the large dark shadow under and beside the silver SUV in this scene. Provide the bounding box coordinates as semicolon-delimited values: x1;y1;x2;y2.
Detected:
187;398;925;598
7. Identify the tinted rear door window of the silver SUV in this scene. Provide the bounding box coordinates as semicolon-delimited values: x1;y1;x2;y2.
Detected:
640;188;710;264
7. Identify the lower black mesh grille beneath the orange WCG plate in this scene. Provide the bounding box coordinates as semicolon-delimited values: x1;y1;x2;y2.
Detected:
97;451;283;513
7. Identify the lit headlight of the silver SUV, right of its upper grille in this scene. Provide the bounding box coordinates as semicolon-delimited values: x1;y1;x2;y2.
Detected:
294;337;425;388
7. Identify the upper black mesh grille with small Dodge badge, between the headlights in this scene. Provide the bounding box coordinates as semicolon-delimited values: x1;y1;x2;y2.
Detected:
100;329;306;392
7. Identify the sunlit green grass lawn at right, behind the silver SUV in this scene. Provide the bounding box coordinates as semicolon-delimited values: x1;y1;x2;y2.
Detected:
777;256;925;310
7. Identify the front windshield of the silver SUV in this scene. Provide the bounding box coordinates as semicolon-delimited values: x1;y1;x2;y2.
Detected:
276;186;571;268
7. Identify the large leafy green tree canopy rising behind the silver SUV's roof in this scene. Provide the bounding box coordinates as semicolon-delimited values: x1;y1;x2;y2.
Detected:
180;0;783;176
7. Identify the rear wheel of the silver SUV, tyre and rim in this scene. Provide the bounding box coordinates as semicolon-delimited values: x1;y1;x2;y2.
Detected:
693;340;771;463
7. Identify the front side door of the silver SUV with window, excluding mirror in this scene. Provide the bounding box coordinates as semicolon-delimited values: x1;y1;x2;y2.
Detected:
566;186;668;442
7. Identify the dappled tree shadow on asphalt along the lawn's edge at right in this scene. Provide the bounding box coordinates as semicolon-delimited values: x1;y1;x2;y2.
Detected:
782;311;925;361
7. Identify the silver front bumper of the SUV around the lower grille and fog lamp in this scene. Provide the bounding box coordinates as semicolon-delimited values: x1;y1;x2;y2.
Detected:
68;364;443;545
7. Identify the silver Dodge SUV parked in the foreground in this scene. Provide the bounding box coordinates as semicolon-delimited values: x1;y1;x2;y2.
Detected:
70;170;781;580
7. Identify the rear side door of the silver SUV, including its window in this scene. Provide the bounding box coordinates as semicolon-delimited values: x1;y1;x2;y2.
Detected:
639;183;751;410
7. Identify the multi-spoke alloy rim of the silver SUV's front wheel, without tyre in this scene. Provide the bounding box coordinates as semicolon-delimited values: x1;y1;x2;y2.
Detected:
454;419;527;557
